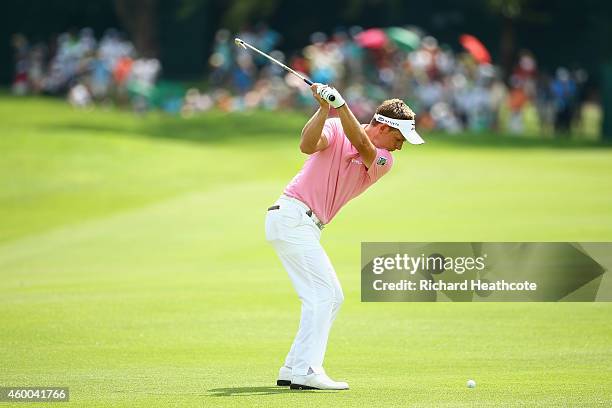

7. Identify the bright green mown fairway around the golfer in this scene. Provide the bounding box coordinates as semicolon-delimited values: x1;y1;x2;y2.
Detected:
0;96;612;408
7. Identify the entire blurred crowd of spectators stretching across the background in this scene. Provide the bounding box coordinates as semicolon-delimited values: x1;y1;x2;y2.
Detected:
12;24;603;138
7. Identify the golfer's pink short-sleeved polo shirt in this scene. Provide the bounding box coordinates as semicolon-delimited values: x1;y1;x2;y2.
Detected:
284;118;393;224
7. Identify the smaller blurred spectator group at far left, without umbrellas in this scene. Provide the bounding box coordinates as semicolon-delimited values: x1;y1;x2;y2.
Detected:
12;28;161;111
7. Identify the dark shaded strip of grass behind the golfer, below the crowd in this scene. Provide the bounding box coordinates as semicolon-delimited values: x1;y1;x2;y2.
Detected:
41;111;612;149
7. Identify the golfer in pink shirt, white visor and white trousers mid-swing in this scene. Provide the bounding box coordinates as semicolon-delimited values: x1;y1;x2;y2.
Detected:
266;84;424;390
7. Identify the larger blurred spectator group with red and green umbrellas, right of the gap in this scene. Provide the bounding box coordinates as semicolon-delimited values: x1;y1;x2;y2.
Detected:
197;24;602;138
